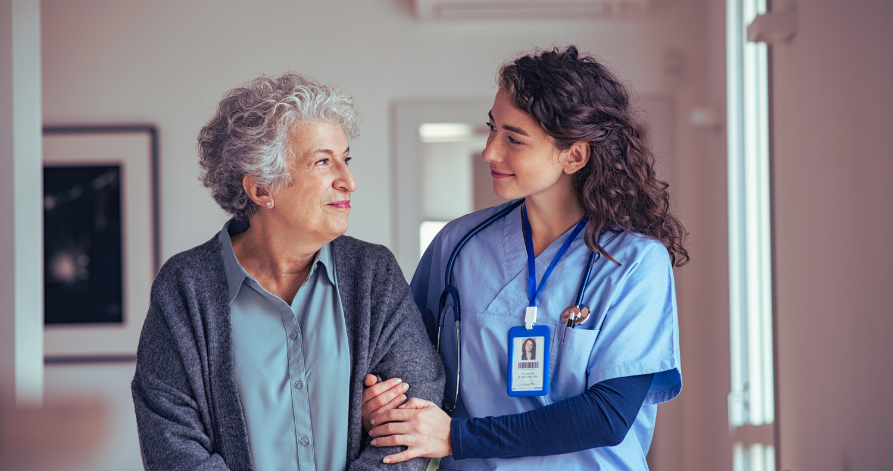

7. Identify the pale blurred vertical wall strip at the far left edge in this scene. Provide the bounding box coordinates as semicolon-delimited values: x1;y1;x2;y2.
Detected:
0;0;43;412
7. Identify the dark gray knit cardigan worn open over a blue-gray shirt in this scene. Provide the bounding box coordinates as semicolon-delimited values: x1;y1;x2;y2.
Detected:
131;236;444;471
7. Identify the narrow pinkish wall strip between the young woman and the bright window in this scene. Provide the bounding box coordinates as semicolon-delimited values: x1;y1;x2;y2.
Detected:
649;1;732;471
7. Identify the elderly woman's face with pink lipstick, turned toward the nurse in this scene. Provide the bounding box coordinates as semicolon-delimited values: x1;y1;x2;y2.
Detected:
273;123;357;245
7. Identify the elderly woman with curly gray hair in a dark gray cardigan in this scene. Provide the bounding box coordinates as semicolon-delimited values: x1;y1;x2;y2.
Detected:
131;74;443;471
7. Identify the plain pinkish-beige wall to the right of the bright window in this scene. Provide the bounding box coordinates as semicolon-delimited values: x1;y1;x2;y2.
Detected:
772;0;893;471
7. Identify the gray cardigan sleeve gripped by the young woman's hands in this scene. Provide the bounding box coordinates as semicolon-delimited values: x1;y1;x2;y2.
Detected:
350;249;444;471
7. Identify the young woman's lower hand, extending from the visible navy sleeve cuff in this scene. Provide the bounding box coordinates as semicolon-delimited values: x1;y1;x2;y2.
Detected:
369;397;453;463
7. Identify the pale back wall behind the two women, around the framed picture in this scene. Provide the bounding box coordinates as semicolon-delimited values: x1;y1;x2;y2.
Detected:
21;0;730;470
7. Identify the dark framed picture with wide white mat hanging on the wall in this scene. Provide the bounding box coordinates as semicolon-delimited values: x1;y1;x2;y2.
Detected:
43;125;159;363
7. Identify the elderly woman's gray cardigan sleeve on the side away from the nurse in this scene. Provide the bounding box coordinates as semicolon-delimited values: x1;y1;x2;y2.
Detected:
131;280;230;471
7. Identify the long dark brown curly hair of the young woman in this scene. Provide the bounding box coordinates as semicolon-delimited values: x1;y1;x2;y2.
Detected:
497;46;689;267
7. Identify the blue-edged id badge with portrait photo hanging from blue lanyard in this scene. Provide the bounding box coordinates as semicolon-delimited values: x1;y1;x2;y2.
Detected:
507;325;551;397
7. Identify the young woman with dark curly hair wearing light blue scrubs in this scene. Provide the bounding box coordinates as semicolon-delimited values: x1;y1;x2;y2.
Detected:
363;46;688;471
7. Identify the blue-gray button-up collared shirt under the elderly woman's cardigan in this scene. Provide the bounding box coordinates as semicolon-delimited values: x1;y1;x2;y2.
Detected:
219;220;350;471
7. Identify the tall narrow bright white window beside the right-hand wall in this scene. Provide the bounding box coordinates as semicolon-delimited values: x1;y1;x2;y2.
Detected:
726;0;775;471
